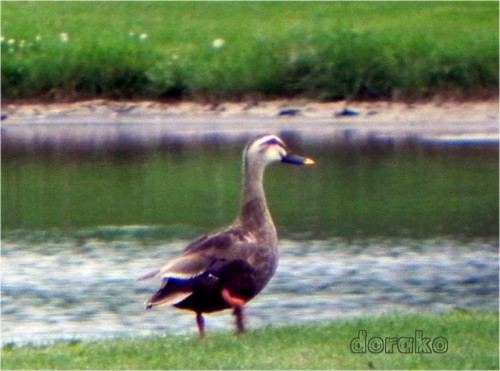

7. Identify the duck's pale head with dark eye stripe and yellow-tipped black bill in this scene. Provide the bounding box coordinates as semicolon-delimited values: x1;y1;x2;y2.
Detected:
244;135;314;166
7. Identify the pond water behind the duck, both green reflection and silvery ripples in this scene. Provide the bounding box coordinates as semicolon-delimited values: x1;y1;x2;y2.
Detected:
1;136;499;344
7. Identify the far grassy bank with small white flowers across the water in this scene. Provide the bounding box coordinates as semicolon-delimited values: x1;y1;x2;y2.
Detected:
1;2;499;101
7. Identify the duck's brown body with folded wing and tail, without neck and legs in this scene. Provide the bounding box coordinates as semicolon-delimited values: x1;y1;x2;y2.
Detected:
145;226;278;312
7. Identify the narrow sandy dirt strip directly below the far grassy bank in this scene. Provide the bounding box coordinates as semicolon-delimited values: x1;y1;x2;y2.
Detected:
2;100;499;125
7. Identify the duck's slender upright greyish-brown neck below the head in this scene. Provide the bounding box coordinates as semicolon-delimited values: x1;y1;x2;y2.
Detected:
239;161;277;244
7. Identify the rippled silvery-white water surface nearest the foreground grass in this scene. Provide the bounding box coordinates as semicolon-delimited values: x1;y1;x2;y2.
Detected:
1;227;499;344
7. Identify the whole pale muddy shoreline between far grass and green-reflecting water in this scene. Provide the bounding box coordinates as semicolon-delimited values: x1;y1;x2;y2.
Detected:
2;100;499;151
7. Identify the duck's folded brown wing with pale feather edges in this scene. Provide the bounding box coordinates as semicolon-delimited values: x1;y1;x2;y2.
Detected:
139;227;255;280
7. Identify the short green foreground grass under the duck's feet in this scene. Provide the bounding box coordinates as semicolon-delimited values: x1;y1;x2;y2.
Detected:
1;311;499;369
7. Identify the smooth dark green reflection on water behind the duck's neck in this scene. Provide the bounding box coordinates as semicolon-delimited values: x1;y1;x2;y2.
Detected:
2;142;499;239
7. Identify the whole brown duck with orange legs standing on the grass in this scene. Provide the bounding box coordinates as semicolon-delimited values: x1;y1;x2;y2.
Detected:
139;134;315;338
